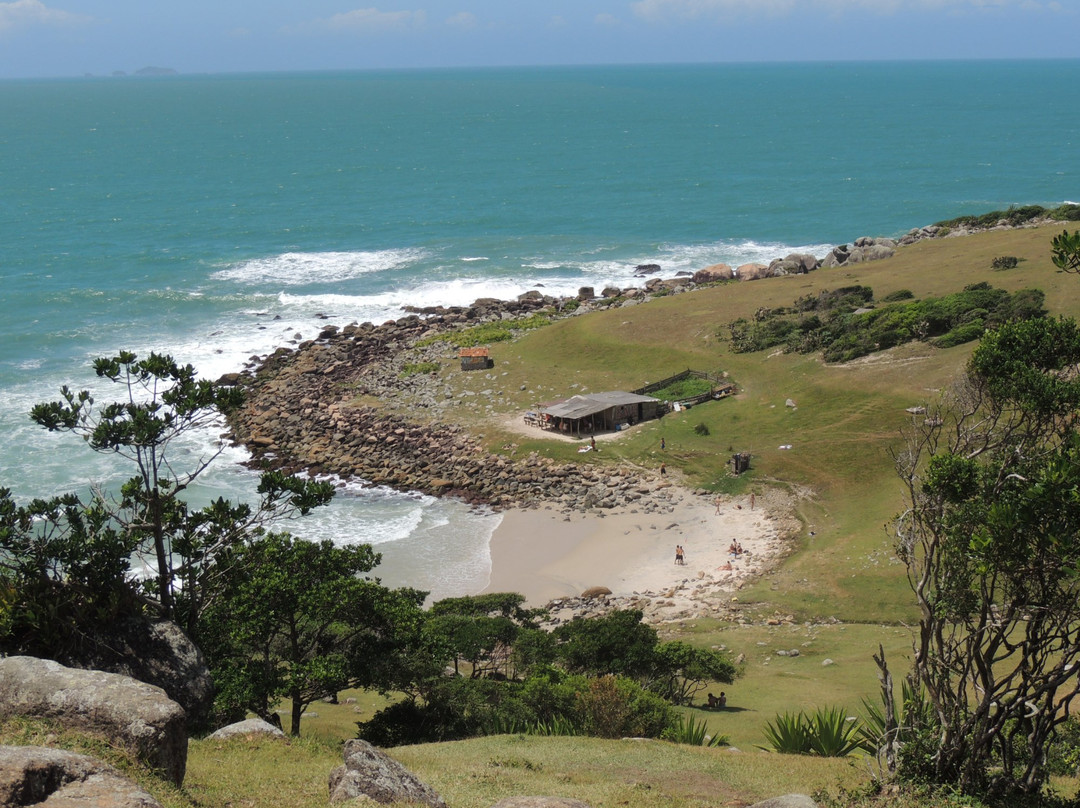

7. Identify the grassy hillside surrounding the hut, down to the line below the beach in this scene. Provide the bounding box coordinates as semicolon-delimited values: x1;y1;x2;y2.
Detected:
444;225;1080;622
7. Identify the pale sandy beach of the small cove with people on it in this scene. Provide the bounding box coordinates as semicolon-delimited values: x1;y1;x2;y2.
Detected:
485;485;797;620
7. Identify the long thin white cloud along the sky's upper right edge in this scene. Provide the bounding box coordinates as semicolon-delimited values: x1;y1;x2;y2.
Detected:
631;0;1056;22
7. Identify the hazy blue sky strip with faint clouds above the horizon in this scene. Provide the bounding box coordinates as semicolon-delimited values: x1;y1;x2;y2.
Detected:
0;0;1080;78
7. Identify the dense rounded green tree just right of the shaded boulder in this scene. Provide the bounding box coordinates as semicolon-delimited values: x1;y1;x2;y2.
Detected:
207;534;427;736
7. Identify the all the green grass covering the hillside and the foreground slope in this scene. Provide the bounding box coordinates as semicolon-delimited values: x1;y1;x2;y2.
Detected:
10;226;1080;808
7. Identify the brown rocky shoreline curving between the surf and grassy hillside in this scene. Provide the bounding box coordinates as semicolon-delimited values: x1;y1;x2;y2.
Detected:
221;228;933;512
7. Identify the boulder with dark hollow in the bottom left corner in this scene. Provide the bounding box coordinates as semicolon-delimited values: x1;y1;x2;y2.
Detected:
0;746;161;808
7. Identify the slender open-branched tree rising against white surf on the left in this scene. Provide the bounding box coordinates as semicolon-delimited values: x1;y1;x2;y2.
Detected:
24;351;334;632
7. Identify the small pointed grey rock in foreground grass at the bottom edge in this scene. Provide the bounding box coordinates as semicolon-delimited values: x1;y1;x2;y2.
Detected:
329;740;446;808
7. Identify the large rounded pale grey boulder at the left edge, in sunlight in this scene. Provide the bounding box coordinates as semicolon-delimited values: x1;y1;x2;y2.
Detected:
0;657;188;785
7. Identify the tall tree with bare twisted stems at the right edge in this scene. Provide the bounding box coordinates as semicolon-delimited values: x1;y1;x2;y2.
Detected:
895;319;1080;798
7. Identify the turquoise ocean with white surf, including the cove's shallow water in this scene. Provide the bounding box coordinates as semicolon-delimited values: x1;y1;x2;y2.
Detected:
0;60;1080;596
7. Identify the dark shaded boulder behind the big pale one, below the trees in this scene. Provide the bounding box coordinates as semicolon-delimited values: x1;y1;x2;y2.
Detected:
57;618;214;731
